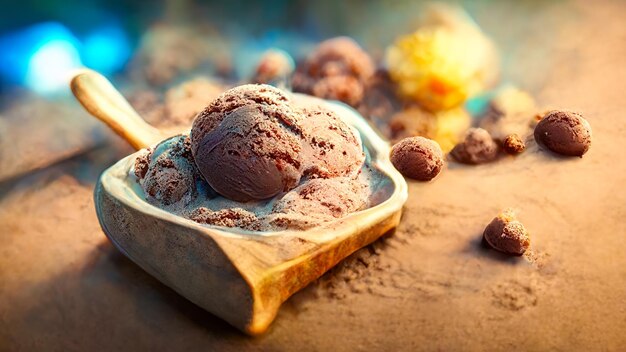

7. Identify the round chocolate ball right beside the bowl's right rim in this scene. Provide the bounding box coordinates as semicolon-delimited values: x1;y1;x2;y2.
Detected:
391;137;443;181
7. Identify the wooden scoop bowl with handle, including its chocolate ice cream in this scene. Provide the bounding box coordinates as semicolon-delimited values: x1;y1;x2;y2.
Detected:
71;70;407;335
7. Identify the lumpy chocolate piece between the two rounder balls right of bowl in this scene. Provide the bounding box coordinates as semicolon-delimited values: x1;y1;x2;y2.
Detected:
450;128;498;164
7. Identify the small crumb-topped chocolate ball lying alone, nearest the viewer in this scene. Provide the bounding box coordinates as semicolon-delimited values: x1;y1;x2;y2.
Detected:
483;209;530;255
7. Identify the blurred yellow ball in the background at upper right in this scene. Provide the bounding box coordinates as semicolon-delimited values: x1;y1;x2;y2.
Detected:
385;5;499;111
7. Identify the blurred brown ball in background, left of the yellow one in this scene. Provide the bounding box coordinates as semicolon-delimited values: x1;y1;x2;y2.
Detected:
292;37;375;106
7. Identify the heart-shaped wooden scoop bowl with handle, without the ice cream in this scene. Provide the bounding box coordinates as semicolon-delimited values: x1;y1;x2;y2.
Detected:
72;71;407;335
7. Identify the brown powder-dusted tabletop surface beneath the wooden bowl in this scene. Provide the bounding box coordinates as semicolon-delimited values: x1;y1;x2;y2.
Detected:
0;2;626;351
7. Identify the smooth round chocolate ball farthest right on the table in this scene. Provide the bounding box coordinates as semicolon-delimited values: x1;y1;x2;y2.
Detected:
535;110;591;157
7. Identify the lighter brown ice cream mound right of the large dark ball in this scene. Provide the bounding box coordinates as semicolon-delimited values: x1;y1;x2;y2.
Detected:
302;106;365;178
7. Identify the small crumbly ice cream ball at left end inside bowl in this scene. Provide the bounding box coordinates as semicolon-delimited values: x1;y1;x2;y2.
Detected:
135;135;200;205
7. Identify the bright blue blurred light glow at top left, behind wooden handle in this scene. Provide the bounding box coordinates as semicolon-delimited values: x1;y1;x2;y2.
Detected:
0;21;131;95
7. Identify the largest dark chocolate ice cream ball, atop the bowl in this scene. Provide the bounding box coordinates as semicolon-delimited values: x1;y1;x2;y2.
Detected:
191;85;303;202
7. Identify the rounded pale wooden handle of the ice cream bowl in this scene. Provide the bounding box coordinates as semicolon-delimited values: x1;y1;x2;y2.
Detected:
70;69;167;150
